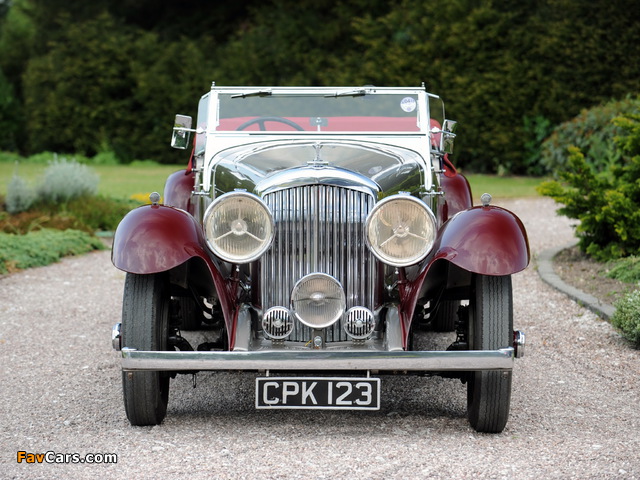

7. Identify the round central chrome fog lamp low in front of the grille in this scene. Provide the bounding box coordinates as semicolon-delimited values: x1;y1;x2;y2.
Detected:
291;273;346;328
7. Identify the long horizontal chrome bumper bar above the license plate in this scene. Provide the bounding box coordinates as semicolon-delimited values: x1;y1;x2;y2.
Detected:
120;347;516;372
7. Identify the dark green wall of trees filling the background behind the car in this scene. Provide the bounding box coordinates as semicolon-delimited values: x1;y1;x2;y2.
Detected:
0;0;640;173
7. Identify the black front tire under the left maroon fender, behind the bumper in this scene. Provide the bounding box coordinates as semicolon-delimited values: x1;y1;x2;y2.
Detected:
122;273;170;426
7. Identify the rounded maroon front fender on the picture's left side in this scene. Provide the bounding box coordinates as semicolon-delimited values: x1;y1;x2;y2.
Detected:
111;205;210;274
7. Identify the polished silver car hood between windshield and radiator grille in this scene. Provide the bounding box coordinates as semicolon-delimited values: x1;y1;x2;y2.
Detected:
212;141;426;198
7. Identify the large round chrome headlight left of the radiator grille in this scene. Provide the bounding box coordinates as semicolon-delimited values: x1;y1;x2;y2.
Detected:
204;192;274;263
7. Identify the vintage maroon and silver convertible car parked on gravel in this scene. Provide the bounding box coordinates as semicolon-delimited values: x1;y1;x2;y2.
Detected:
112;84;529;432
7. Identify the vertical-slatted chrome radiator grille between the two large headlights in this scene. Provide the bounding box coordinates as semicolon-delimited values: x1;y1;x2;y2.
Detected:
261;185;375;342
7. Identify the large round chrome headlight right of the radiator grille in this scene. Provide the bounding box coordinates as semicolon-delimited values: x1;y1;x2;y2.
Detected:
366;195;437;267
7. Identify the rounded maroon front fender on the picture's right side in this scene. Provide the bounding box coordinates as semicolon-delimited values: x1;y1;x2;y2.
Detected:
433;206;530;275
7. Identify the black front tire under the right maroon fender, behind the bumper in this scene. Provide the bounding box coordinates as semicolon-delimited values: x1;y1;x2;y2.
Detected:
467;275;513;433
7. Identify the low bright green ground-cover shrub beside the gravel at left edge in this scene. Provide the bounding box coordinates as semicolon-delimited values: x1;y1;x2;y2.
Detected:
0;229;105;273
